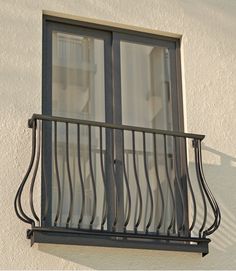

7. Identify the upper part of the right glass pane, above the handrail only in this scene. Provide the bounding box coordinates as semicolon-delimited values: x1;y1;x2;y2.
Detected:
121;41;172;130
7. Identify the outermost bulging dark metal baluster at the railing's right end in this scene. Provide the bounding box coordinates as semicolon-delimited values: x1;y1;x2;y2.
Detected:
198;140;221;237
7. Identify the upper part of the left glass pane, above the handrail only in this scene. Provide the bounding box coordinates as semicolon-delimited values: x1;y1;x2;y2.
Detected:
52;32;105;121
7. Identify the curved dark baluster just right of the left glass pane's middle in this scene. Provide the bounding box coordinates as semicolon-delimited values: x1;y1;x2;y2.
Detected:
88;125;97;228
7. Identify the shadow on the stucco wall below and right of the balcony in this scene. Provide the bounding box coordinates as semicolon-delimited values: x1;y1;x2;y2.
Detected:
37;145;236;269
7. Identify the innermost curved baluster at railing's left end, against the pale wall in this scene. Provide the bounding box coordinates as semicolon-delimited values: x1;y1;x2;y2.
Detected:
30;120;41;222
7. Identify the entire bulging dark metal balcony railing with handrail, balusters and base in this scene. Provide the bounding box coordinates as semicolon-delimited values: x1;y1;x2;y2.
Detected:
14;114;221;254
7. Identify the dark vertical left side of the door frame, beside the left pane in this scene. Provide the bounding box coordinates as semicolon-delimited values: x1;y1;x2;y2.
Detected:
41;20;53;230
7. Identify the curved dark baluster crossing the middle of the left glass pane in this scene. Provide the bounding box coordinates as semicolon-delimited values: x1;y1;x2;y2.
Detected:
77;124;85;228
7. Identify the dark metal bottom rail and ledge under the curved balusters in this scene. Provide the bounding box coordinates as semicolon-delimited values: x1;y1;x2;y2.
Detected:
27;227;210;256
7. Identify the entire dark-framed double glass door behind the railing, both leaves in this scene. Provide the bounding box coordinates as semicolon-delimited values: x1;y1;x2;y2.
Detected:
42;22;182;234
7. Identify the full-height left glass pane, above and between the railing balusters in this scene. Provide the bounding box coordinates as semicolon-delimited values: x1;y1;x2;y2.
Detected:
52;32;105;228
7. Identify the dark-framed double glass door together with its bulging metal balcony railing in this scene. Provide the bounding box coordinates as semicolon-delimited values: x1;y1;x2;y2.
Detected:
15;17;220;258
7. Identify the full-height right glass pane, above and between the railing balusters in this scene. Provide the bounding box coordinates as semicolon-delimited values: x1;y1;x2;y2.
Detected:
120;41;174;233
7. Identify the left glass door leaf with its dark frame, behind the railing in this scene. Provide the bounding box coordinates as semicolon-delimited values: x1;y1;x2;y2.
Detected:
43;23;113;229
